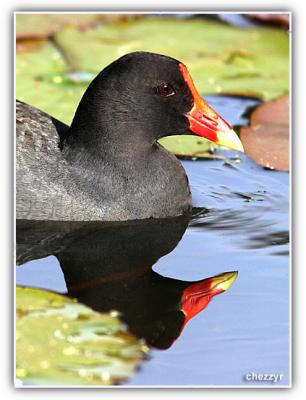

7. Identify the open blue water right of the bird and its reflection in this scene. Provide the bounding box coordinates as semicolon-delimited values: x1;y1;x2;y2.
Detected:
130;157;289;385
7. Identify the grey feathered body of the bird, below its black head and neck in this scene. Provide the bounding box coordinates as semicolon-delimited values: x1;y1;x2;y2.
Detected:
16;102;191;221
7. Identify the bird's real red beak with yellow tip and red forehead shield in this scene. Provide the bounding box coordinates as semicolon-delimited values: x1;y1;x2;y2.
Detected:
179;64;244;152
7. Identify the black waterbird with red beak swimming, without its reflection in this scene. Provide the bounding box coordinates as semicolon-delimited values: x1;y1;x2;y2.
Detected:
16;52;243;221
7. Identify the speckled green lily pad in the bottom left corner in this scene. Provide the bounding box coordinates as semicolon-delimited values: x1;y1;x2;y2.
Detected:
16;287;147;386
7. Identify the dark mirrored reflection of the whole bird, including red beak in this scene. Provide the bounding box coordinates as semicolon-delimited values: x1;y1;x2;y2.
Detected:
17;217;237;349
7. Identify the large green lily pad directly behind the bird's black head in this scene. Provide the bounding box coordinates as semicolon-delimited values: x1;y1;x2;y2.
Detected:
55;17;289;100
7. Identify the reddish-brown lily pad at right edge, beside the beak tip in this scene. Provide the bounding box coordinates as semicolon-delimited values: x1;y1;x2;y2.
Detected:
240;95;289;171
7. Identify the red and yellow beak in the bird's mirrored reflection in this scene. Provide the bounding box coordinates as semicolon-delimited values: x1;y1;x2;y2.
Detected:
181;271;238;327
